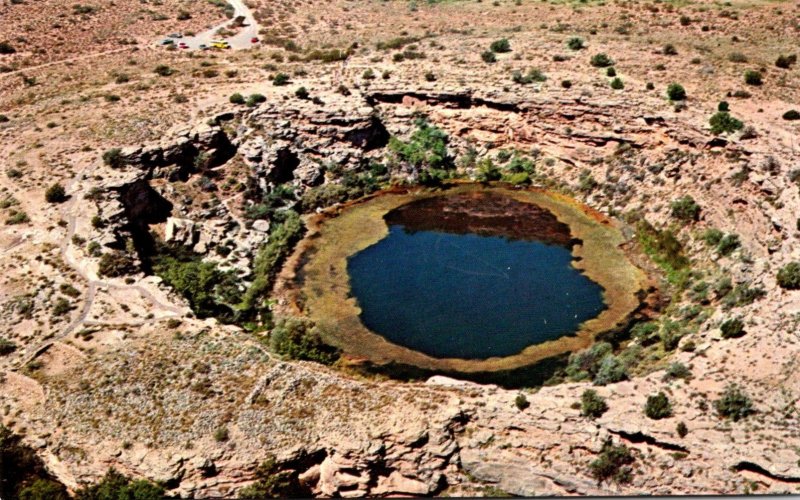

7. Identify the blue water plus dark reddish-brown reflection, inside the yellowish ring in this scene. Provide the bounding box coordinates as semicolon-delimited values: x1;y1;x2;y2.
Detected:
347;194;606;360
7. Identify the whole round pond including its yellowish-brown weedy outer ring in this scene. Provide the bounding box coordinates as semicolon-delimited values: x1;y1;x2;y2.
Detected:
279;184;646;372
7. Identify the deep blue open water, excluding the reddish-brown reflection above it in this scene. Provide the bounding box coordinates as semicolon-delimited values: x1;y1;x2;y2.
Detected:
348;225;605;359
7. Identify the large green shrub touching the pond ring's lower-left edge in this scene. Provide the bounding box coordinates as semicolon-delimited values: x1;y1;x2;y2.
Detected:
269;317;339;365
